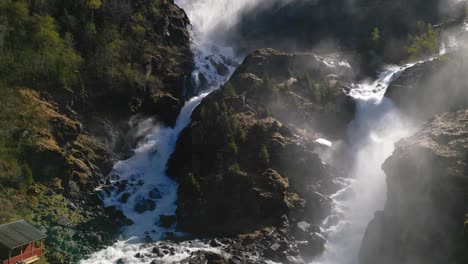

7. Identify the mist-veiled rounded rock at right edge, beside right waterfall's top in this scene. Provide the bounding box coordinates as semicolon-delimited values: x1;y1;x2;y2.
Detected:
385;51;468;120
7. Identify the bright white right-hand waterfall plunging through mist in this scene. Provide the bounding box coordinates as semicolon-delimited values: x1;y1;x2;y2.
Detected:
313;64;415;264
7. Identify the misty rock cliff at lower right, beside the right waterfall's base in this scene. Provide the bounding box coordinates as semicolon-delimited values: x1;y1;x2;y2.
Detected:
360;110;468;264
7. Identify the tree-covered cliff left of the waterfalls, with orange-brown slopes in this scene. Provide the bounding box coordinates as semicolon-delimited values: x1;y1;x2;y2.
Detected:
0;0;193;263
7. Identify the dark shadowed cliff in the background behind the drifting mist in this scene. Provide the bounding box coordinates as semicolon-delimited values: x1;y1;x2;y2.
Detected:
232;0;465;64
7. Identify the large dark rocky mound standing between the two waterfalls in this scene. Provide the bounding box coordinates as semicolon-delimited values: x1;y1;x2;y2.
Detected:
168;50;354;235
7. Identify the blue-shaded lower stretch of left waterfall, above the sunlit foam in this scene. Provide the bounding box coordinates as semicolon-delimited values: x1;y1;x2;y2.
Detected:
104;92;209;240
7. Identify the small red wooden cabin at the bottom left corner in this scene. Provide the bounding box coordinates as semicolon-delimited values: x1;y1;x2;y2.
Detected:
0;220;46;264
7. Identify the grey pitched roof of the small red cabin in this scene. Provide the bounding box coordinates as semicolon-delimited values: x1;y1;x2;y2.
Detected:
0;220;46;249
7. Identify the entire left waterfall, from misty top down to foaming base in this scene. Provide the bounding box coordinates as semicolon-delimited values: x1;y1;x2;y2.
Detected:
80;0;255;264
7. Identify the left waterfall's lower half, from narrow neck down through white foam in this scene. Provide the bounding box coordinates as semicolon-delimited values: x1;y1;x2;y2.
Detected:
81;92;221;264
